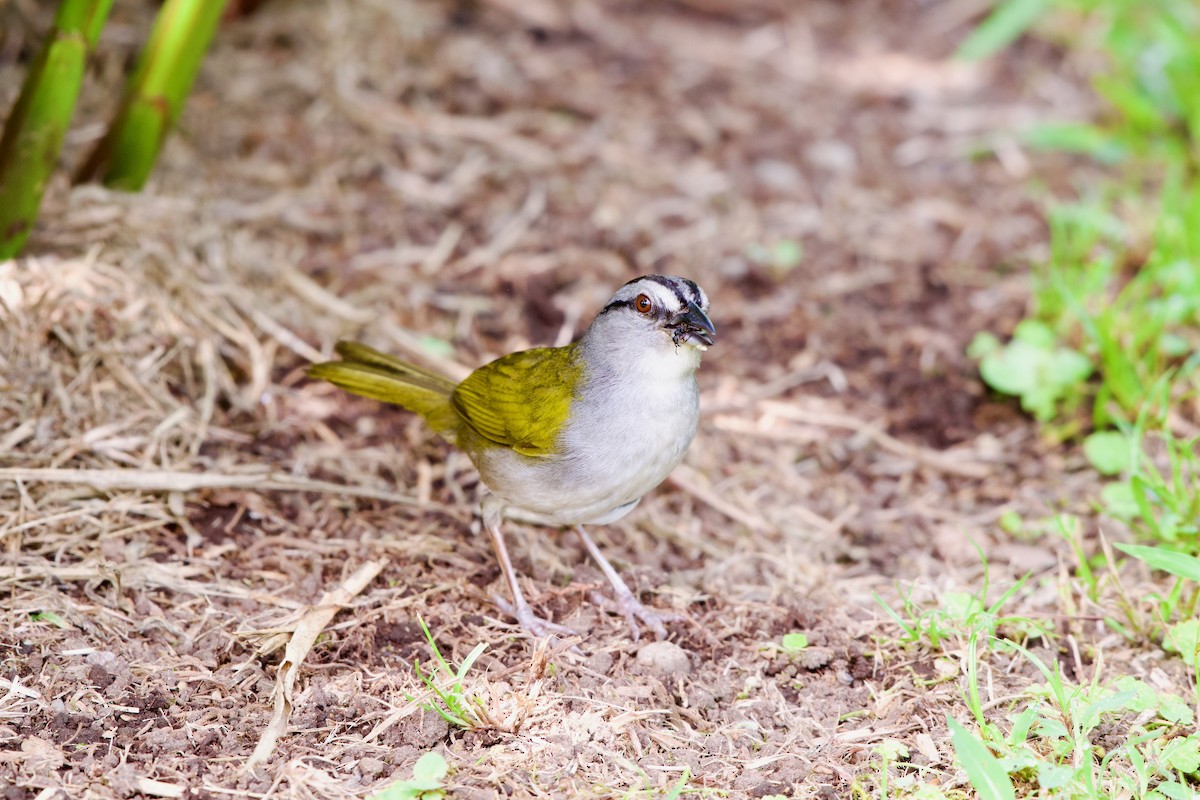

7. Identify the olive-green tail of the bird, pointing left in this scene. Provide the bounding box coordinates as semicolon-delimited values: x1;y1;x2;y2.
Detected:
307;342;462;441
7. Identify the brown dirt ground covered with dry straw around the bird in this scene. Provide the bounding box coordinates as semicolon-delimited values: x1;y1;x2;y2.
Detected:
0;0;1153;800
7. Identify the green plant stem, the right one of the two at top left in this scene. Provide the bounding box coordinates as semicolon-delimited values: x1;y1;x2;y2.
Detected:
77;0;228;192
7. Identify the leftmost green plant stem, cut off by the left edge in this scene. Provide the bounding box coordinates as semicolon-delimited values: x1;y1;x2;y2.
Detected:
0;0;113;258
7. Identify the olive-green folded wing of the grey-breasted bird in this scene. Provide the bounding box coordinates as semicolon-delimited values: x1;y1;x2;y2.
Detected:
452;345;583;456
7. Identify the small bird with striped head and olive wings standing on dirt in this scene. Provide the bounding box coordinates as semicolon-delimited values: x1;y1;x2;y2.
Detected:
307;275;716;642
